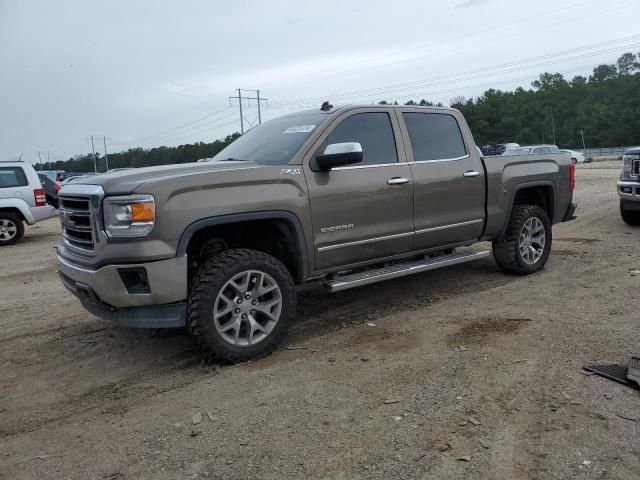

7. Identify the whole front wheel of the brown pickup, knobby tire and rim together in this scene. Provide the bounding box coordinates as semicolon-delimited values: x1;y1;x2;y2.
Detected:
188;249;296;362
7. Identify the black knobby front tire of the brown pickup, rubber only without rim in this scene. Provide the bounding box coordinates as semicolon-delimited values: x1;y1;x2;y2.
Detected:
187;249;296;363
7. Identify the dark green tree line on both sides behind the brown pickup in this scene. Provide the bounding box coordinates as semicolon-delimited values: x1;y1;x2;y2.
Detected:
54;53;640;172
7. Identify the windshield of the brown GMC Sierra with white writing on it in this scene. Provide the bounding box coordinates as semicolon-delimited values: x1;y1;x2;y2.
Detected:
213;113;328;165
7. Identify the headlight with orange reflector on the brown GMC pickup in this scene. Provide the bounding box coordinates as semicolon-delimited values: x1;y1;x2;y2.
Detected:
102;195;156;237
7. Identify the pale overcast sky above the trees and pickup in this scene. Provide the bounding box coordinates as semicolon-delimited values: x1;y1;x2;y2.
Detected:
0;0;640;163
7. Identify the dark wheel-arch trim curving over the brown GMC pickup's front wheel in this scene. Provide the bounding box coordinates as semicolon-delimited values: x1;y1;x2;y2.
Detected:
176;210;309;283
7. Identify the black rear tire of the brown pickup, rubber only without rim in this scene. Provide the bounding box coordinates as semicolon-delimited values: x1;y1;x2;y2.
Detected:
493;205;552;275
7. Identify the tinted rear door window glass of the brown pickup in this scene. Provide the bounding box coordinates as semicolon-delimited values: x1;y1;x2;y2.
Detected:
402;112;467;162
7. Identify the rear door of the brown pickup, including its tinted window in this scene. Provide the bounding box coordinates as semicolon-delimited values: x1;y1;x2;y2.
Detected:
398;108;485;249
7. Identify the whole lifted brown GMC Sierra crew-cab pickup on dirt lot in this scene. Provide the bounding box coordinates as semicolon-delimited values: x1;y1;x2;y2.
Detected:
57;103;576;361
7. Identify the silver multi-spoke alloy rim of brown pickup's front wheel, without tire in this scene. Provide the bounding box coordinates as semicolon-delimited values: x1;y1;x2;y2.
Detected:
213;270;282;347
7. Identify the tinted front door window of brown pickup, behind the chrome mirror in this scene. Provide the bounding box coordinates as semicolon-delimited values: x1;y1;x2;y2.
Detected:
328;112;398;165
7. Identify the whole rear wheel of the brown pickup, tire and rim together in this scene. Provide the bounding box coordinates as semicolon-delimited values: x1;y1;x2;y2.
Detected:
493;205;552;275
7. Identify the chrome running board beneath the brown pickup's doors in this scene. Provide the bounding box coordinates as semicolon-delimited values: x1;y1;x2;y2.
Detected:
324;250;491;292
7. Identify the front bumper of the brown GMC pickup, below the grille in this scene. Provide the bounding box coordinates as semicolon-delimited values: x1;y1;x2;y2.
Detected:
58;255;187;328
